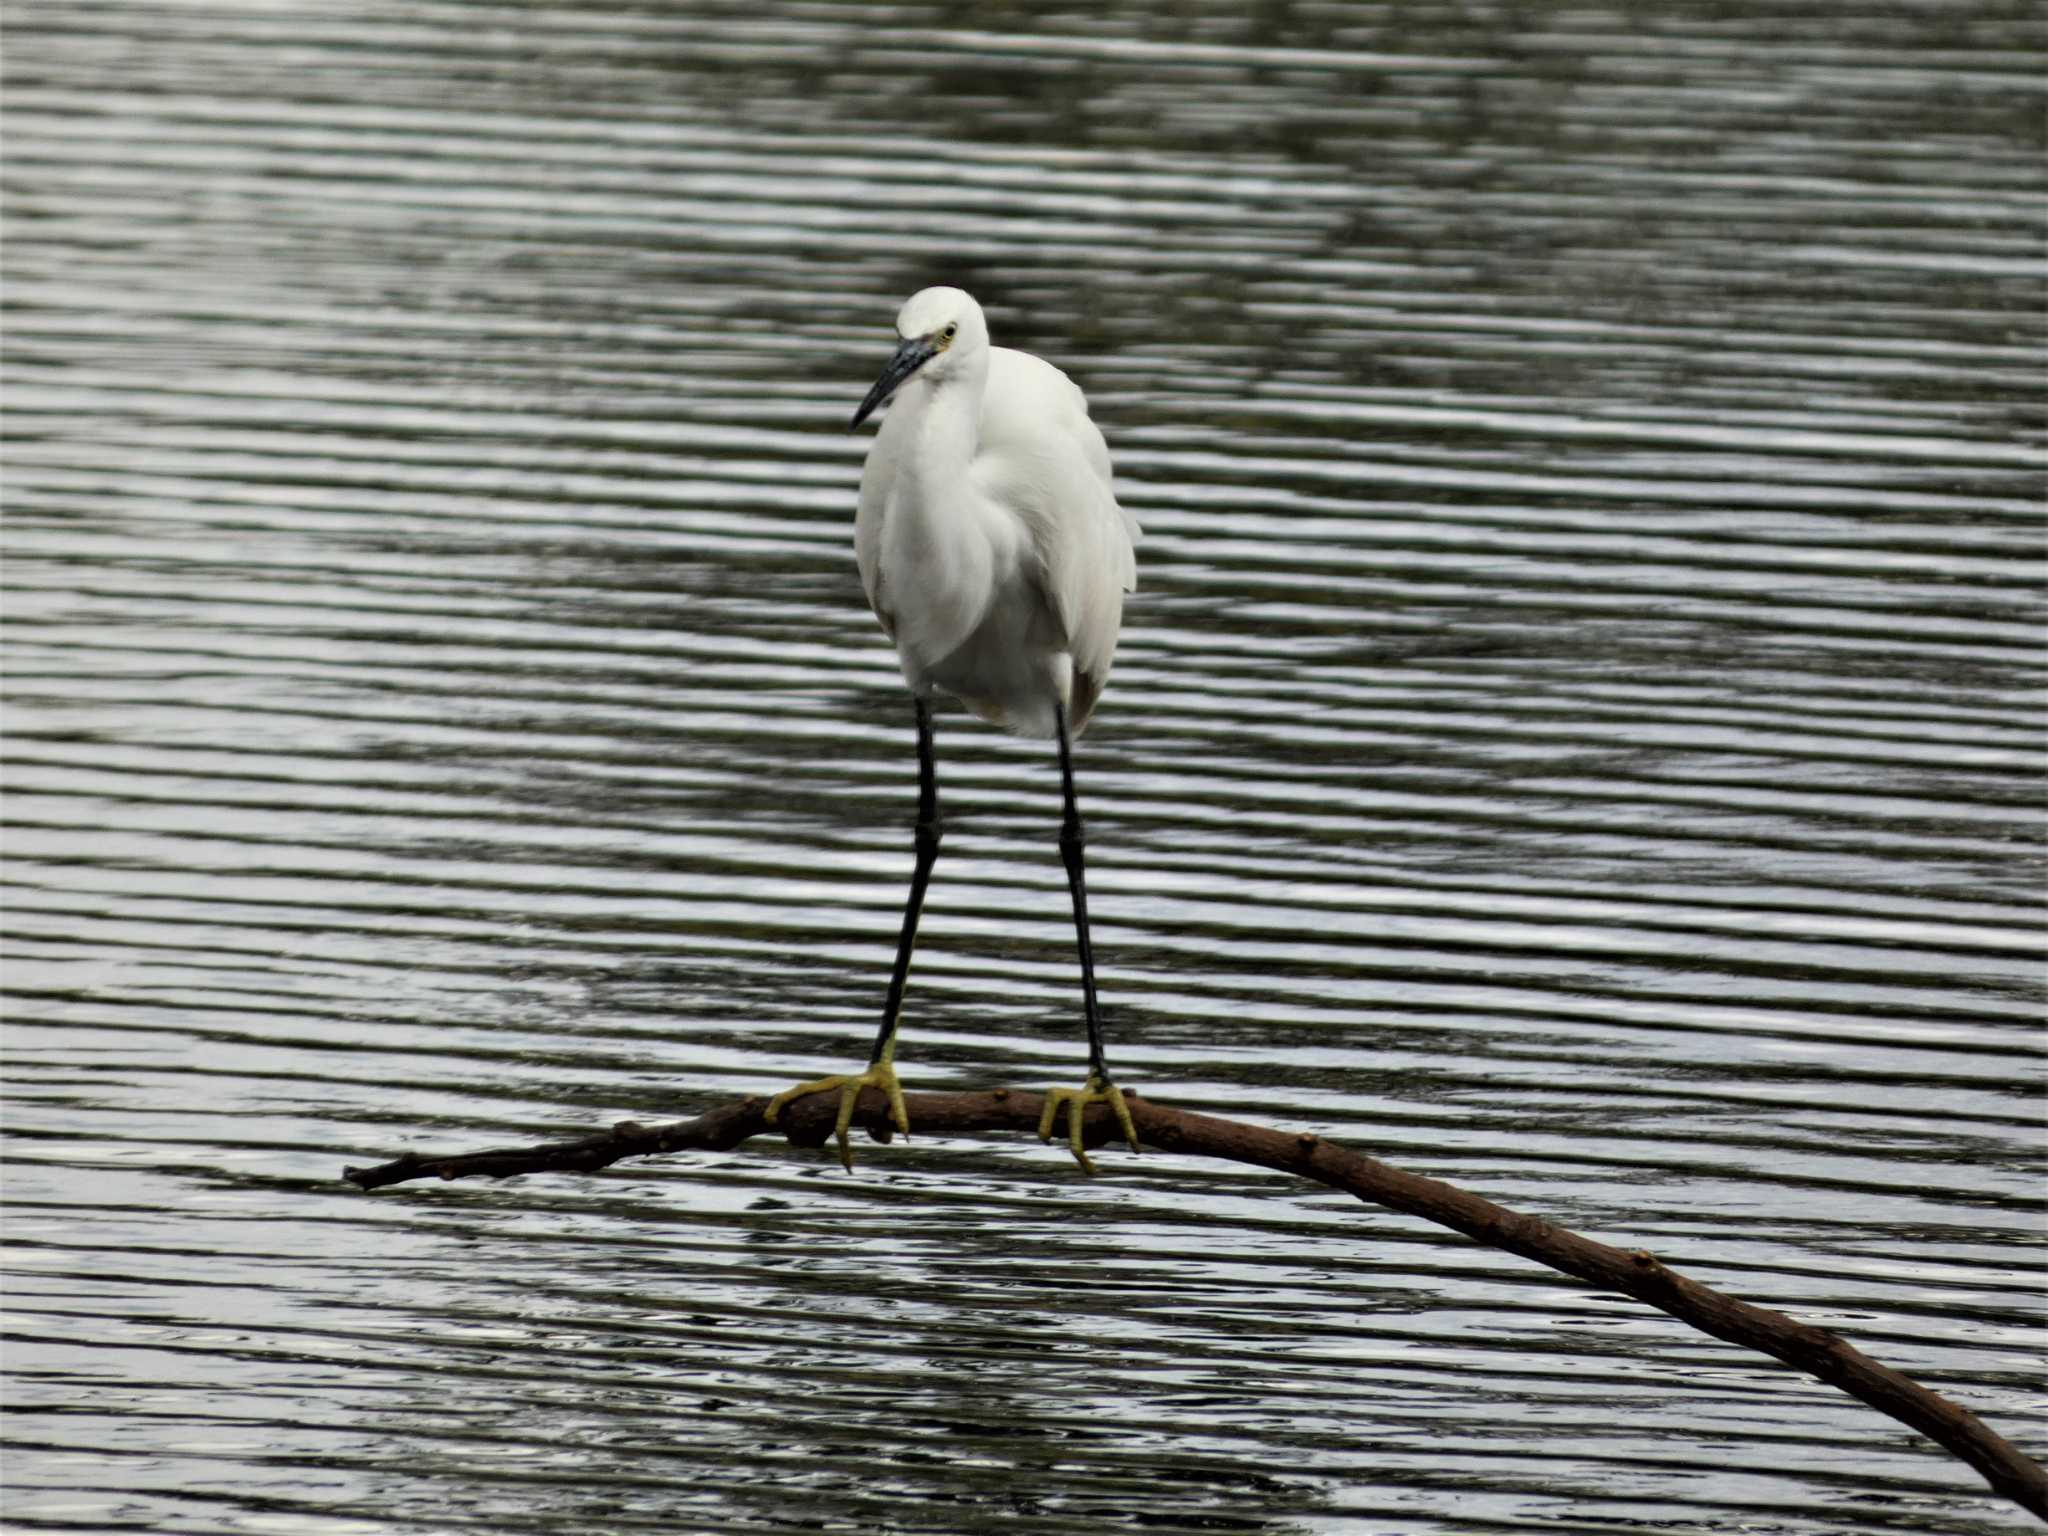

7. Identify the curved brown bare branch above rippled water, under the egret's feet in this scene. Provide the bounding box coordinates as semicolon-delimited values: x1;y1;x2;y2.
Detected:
342;1087;2048;1522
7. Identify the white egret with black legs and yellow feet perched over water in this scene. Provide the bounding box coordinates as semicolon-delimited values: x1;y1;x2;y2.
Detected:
768;289;1139;1174
